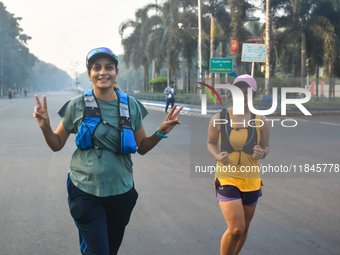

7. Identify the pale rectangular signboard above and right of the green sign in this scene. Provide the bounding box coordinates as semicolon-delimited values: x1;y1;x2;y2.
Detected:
241;43;266;62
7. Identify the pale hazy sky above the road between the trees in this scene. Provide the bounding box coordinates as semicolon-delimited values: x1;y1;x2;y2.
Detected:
0;0;155;73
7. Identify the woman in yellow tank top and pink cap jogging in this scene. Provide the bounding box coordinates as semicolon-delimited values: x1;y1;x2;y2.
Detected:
207;74;269;255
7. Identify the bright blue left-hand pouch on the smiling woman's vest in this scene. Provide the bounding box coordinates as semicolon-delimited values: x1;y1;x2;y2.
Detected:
76;117;100;150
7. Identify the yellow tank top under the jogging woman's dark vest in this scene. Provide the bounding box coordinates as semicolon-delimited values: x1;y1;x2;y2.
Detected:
215;109;263;192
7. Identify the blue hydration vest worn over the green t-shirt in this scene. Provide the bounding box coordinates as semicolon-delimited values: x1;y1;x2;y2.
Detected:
76;89;137;154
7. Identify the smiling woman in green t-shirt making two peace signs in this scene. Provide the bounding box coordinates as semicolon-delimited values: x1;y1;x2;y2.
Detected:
33;48;183;255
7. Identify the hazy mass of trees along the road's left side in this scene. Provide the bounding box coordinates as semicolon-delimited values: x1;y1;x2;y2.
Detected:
0;2;70;93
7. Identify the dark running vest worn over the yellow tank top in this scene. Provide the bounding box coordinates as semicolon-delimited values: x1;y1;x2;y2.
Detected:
220;109;258;165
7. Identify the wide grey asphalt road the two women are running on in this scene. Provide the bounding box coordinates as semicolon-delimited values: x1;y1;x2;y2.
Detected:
0;92;340;255
